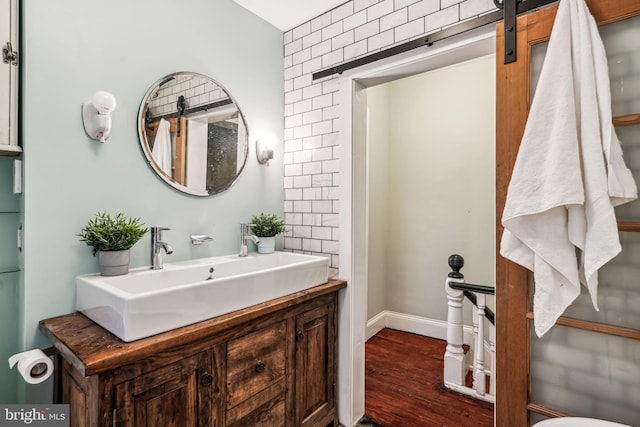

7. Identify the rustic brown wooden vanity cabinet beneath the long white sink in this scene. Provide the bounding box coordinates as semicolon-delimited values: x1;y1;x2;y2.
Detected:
40;281;346;427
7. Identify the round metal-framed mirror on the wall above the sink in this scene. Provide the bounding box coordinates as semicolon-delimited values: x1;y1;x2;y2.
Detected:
138;72;249;196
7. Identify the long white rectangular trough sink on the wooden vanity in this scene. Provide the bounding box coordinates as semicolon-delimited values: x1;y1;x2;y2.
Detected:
76;252;328;341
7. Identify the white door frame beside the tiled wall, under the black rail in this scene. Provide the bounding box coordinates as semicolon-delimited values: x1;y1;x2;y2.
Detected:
338;25;496;426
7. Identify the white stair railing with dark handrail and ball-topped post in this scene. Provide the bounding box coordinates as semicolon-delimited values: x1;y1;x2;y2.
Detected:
444;255;496;402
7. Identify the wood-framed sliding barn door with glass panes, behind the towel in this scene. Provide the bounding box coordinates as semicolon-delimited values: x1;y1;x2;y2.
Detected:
496;0;640;427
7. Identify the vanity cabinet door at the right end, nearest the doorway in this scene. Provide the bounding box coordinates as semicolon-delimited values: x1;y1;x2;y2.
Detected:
295;303;337;427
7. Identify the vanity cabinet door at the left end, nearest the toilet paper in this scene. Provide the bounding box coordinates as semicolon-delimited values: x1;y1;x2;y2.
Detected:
114;351;216;427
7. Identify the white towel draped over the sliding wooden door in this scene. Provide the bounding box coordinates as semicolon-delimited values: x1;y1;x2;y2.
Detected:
500;0;637;336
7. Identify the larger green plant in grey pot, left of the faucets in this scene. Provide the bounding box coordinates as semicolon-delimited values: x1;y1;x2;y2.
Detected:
78;212;149;276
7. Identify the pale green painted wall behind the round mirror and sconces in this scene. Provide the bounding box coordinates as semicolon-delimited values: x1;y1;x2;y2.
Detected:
0;0;284;402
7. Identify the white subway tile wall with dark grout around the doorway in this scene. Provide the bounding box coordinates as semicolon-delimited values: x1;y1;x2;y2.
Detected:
284;0;495;270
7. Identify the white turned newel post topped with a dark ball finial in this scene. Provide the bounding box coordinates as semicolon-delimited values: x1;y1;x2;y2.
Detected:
444;255;466;386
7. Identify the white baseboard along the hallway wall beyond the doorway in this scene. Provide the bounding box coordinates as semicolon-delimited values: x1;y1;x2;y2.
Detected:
366;310;473;345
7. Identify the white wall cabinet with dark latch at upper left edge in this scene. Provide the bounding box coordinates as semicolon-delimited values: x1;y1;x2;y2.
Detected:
0;0;22;156
